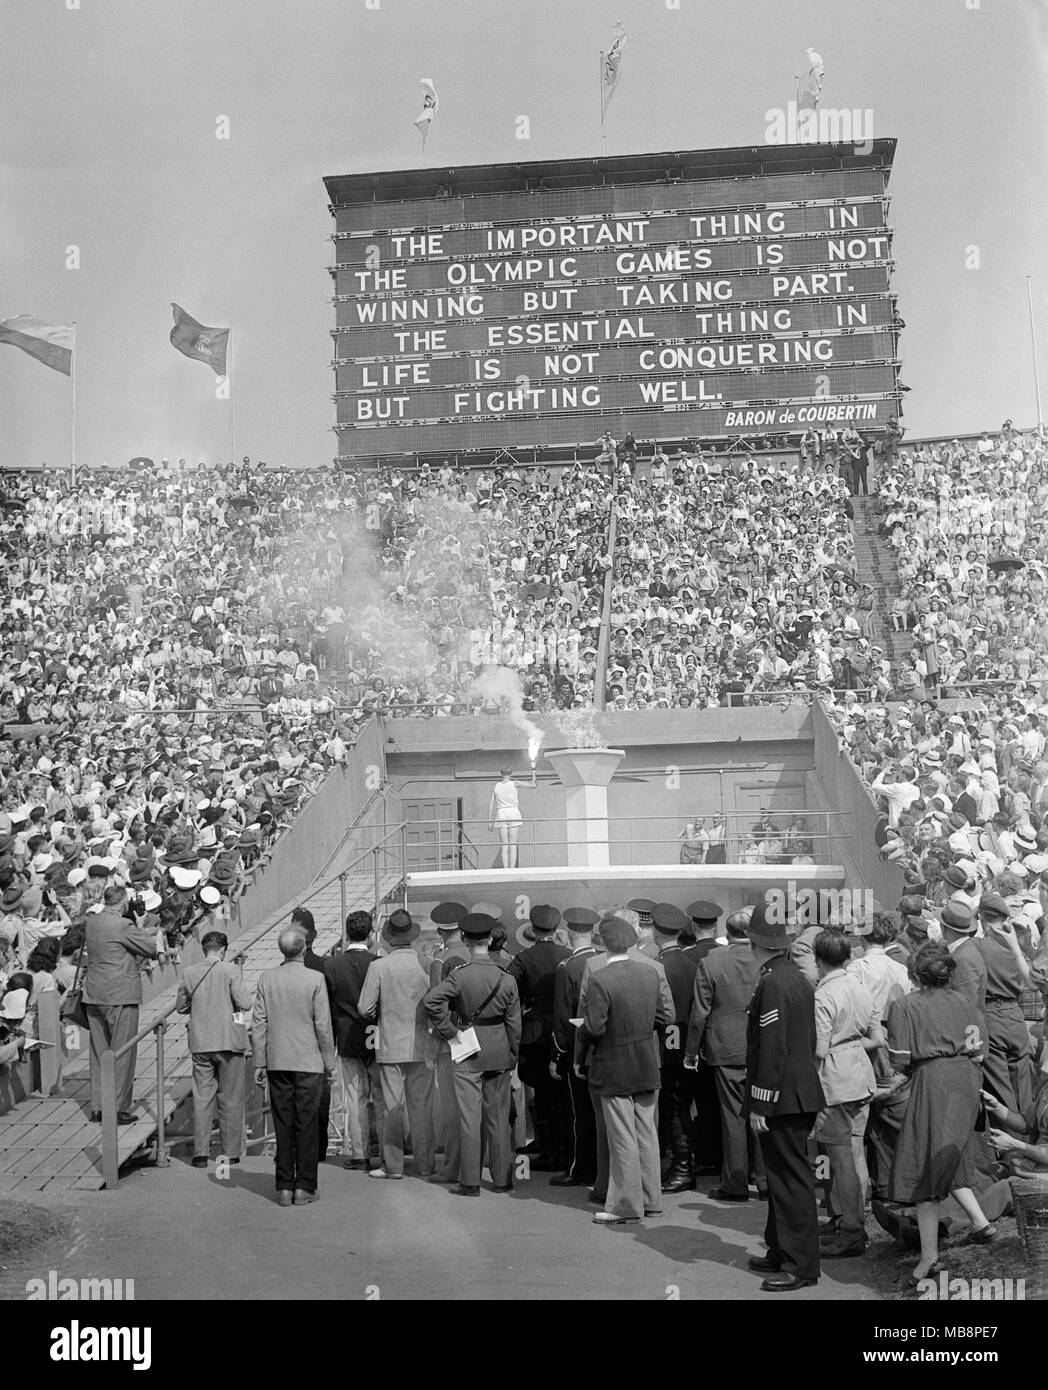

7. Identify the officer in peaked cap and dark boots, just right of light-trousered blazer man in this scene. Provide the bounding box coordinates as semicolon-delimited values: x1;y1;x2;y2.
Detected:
652;902;696;1193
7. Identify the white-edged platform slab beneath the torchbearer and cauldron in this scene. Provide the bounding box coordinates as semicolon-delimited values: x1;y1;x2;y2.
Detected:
406;863;845;923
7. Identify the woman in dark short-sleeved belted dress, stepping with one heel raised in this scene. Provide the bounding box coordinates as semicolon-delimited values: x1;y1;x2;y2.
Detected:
887;941;994;1282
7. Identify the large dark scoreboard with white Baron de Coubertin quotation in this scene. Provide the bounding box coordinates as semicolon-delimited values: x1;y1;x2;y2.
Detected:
325;140;899;461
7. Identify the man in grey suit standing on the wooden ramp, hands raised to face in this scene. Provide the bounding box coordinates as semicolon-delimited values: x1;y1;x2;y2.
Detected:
82;885;157;1125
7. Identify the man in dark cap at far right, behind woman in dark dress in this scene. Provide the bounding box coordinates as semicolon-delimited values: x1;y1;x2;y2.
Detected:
974;892;1033;1113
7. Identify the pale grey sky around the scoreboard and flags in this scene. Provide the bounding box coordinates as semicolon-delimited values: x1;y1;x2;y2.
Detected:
0;0;1048;467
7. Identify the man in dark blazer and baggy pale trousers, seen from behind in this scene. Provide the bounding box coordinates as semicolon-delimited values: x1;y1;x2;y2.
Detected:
578;917;673;1226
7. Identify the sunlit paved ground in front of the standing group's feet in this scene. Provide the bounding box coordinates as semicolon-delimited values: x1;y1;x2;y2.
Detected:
0;1156;878;1301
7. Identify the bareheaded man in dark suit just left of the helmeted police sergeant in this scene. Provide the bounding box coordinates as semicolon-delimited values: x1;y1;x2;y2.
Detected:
684;908;767;1202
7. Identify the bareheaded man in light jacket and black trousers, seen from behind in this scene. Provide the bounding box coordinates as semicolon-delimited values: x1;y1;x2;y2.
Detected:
252;927;335;1207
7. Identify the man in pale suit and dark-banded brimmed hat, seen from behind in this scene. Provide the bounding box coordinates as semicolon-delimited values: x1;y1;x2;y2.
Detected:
357;908;434;1179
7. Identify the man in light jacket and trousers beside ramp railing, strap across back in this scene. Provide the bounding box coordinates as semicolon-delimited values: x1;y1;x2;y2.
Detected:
175;931;252;1168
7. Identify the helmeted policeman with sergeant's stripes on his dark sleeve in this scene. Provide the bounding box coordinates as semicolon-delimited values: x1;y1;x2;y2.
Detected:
746;905;824;1293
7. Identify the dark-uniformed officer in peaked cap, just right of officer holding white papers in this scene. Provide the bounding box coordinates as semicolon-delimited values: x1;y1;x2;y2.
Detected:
509;904;571;1173
